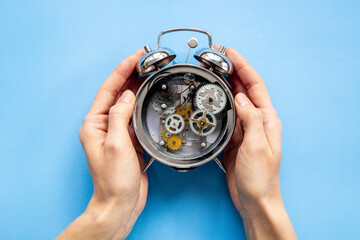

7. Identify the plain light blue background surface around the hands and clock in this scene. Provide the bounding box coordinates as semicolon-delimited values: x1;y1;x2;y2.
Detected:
0;0;360;239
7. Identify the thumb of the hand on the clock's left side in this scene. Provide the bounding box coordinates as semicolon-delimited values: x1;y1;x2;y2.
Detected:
107;90;135;142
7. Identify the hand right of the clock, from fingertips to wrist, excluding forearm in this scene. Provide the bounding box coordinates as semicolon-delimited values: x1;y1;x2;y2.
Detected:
224;48;282;214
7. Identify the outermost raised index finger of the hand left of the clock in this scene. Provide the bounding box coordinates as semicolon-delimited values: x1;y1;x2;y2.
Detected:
89;49;144;114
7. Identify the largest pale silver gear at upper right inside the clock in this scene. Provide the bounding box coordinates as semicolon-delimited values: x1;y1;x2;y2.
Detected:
194;84;227;114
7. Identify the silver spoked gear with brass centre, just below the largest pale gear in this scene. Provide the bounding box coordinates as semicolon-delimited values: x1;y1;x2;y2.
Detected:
190;110;216;136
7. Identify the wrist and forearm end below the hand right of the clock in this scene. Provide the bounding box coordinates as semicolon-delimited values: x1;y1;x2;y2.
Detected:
241;196;297;240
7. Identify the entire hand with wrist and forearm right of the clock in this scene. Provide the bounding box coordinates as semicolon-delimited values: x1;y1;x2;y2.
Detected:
224;48;296;239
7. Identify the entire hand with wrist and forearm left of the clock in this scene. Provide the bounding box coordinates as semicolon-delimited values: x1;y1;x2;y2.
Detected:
58;49;148;239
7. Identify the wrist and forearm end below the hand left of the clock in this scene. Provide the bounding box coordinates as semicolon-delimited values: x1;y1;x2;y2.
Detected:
56;200;135;240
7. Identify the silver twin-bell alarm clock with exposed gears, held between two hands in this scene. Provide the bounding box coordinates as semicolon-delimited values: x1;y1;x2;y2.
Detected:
133;28;236;171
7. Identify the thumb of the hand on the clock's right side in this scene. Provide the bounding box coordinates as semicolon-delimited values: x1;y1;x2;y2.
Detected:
235;93;267;149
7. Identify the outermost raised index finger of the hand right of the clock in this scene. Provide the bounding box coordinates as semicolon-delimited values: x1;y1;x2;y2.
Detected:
226;48;273;110
